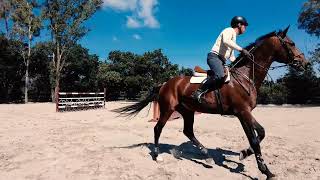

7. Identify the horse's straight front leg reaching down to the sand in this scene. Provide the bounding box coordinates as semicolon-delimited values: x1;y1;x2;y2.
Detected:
238;111;275;179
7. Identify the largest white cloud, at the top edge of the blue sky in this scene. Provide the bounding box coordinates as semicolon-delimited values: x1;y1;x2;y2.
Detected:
103;0;160;28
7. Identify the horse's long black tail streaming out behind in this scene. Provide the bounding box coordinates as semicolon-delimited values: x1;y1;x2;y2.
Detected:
112;85;162;116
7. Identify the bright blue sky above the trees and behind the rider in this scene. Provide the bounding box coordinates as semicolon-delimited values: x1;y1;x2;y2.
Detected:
81;0;319;78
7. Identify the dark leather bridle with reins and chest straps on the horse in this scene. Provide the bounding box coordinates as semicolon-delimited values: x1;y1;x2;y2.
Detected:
230;34;303;95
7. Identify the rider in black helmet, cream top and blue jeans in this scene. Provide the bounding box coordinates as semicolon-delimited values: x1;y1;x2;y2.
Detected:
192;16;250;103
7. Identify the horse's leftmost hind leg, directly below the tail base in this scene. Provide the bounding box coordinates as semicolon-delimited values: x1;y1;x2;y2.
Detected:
153;108;174;160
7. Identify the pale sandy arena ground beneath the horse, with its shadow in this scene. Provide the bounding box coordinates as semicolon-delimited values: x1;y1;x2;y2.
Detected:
0;102;320;180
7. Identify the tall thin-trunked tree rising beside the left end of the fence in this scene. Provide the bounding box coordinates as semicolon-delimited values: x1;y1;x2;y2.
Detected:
43;0;102;99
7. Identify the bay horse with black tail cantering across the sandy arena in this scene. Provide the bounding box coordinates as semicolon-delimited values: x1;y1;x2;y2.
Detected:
115;26;309;179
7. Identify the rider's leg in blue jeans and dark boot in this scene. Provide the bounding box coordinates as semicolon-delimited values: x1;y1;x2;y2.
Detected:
192;53;224;103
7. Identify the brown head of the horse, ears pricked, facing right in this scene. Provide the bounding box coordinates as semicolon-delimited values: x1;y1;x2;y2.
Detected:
275;26;309;70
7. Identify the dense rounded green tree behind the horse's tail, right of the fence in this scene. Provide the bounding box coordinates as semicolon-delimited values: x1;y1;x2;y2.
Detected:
99;49;180;98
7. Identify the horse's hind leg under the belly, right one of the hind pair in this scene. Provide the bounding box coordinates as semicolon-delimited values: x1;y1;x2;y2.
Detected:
178;106;209;157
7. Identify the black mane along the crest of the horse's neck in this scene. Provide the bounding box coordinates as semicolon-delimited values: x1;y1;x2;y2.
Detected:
231;31;277;67
